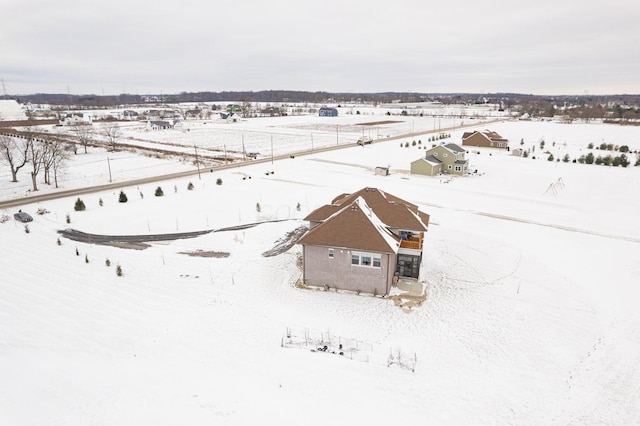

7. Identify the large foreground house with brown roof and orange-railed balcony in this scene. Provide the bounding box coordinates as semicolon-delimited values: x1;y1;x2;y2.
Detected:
297;188;429;295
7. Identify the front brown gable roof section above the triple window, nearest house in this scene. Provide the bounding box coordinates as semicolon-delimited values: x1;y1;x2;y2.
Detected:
297;197;400;253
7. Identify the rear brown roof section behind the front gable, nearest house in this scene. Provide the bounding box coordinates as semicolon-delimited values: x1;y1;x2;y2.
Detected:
305;187;429;231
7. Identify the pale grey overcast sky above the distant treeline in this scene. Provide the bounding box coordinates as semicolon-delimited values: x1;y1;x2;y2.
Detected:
0;0;640;95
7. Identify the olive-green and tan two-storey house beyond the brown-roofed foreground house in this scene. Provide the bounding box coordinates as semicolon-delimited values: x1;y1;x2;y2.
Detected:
411;143;469;176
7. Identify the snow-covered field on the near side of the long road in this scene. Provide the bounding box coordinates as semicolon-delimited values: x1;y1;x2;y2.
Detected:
0;115;640;425
